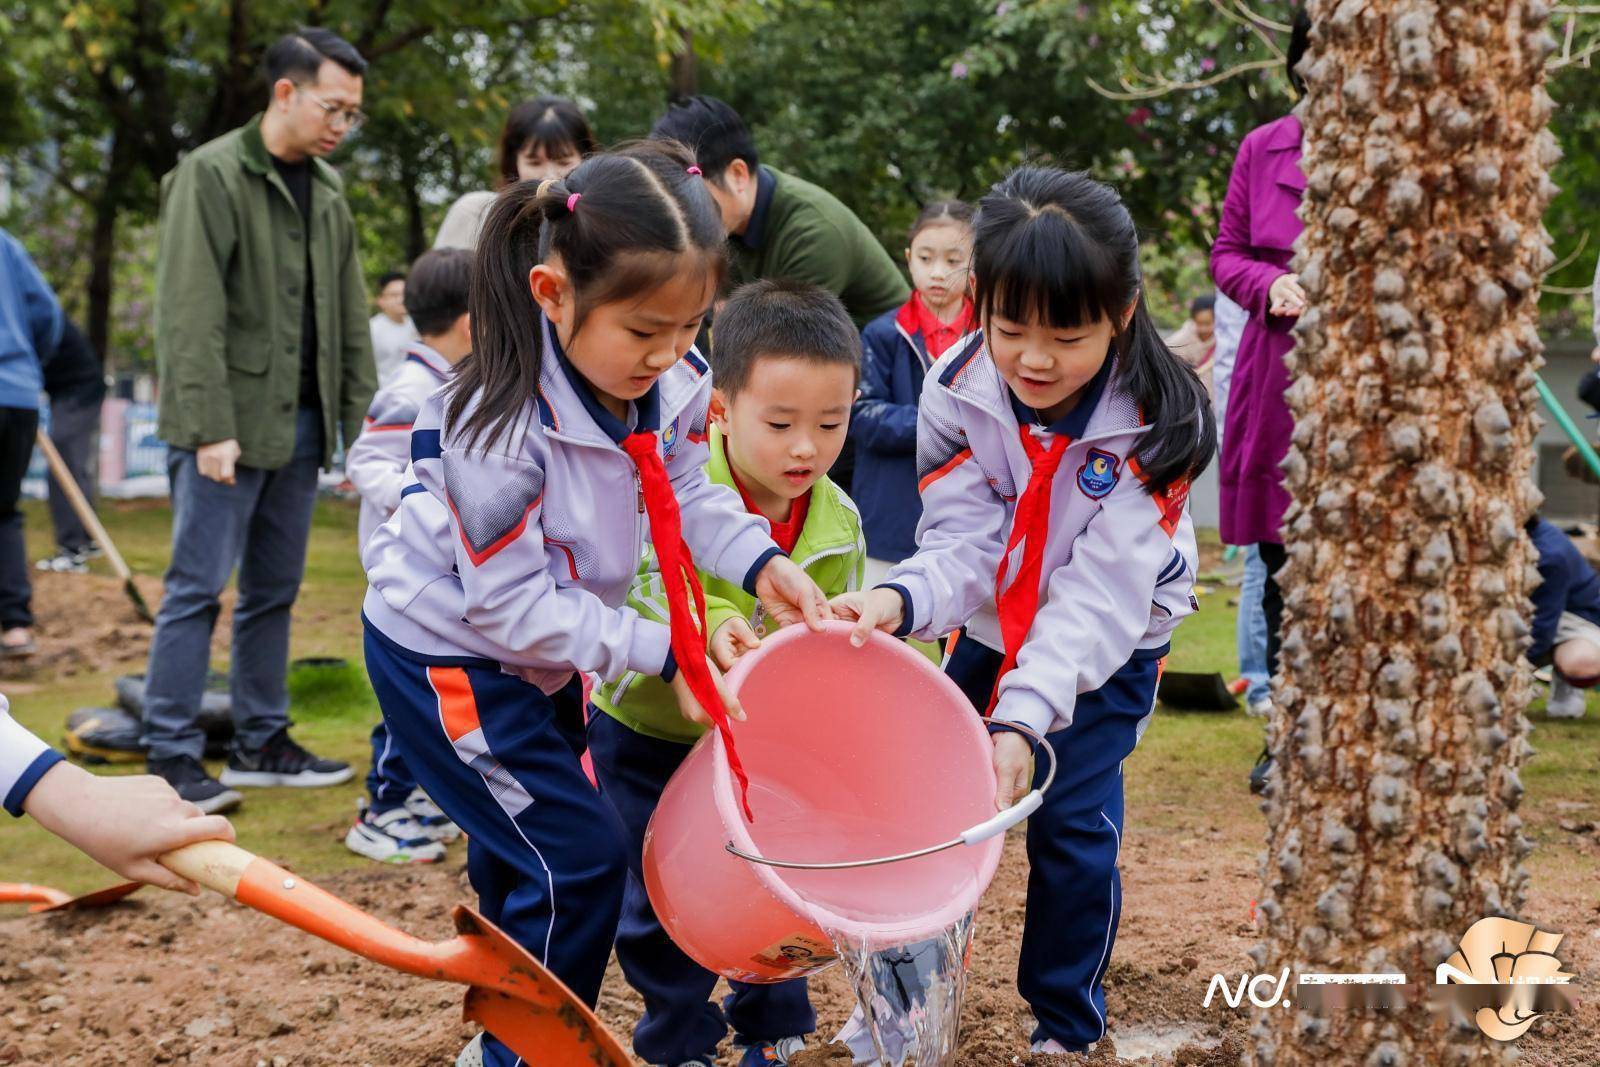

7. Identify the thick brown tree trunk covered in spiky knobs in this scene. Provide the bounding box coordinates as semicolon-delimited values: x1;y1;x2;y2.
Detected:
1253;0;1557;1067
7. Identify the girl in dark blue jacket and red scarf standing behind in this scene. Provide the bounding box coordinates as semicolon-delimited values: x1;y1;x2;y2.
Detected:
851;200;979;589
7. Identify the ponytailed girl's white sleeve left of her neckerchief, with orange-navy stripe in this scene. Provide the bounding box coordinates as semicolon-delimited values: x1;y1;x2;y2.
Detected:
413;448;669;681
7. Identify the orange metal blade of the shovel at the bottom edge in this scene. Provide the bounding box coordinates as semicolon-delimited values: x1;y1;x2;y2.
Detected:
451;905;634;1067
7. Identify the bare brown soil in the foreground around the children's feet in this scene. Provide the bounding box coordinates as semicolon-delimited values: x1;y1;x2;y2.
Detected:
0;809;1600;1067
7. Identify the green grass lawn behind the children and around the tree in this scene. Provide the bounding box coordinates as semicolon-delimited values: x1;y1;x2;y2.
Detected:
0;501;1600;893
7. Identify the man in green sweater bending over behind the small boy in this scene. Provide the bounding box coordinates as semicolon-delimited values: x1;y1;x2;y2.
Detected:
650;96;910;493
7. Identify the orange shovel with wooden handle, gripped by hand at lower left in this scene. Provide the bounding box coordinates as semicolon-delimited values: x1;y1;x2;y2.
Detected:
160;841;634;1067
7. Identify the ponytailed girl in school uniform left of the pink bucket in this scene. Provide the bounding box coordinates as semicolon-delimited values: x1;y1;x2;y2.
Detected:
363;142;829;1067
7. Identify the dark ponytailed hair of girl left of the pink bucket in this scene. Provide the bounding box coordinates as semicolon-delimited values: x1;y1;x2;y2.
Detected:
445;141;728;448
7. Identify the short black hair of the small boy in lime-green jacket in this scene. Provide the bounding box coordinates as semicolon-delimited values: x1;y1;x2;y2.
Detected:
710;278;861;398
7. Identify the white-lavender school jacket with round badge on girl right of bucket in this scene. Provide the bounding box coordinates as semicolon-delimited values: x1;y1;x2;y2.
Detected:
883;346;1200;733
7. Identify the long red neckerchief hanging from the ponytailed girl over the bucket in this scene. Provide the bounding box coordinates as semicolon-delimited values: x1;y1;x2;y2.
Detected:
622;430;755;822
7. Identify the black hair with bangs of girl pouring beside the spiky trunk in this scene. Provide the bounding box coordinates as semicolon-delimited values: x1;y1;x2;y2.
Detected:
973;166;1216;493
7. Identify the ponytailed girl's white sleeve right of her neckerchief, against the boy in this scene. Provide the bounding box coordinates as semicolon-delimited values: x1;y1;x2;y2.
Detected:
666;397;782;595
